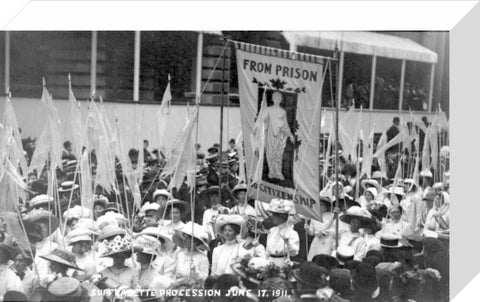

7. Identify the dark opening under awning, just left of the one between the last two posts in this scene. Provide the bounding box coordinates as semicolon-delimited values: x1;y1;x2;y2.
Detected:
373;57;402;110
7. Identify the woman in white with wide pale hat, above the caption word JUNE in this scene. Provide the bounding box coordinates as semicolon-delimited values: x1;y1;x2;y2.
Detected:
211;215;248;276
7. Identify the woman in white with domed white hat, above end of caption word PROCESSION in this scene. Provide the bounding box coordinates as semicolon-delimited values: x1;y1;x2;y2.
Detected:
174;221;210;282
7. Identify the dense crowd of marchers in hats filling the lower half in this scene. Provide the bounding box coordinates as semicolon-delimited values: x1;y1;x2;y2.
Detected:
0;137;450;301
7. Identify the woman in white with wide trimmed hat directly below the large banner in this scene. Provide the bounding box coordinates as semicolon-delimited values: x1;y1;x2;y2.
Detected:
266;199;300;266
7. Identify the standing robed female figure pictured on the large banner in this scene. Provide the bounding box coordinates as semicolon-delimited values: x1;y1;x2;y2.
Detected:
265;91;295;180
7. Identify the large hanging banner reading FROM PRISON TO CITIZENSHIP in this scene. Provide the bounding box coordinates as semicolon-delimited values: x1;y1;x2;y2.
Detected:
235;42;324;220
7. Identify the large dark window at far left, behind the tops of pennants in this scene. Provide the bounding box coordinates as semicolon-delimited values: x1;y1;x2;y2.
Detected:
10;31;91;99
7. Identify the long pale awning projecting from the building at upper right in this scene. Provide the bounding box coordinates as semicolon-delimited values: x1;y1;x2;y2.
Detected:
282;31;437;63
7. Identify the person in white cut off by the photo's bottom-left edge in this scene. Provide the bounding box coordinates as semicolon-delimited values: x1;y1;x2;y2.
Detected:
0;233;23;300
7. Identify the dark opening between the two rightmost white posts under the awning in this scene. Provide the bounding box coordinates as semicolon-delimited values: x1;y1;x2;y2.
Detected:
402;61;431;111
